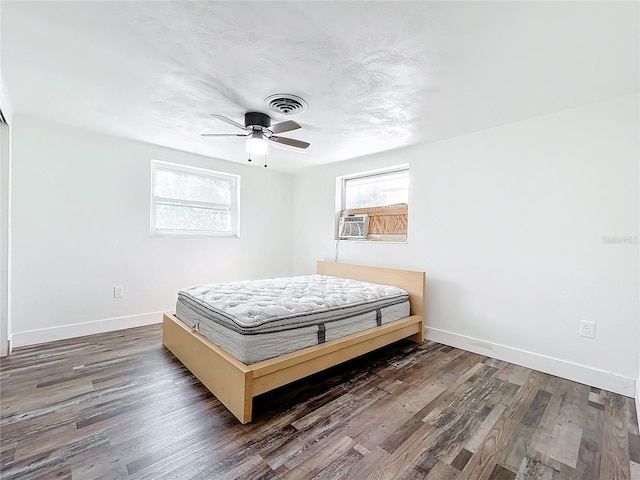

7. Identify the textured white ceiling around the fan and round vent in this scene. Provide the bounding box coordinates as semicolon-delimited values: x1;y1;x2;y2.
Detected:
0;0;640;172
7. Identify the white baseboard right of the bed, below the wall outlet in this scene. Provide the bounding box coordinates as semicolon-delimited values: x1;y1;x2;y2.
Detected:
426;327;638;398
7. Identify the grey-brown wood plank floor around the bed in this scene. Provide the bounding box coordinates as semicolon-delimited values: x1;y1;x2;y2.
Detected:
0;325;640;480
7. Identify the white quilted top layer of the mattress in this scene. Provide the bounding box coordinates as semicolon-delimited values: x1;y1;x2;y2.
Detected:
178;275;408;334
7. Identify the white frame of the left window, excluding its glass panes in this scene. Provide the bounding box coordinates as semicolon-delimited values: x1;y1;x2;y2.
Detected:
149;160;240;238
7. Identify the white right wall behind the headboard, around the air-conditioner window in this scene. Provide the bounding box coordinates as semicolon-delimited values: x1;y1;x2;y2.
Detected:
292;95;639;396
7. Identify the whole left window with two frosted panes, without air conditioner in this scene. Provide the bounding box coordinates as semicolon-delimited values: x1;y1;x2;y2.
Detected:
151;160;240;237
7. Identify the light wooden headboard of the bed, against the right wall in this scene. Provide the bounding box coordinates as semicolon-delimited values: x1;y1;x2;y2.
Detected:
316;260;425;317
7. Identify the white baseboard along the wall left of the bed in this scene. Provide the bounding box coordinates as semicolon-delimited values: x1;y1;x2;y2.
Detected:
11;312;165;349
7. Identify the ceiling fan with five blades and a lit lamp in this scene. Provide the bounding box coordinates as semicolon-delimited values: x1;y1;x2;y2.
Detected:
201;112;310;161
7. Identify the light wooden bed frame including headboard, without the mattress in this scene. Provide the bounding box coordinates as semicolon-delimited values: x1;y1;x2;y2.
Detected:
162;261;425;423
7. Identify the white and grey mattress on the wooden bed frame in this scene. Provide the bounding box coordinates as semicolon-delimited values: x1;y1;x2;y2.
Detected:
176;275;410;364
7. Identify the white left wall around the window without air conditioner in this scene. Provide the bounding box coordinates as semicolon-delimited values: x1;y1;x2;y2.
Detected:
12;114;292;346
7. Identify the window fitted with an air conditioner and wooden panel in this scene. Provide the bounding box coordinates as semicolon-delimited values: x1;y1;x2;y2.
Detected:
338;165;409;242
